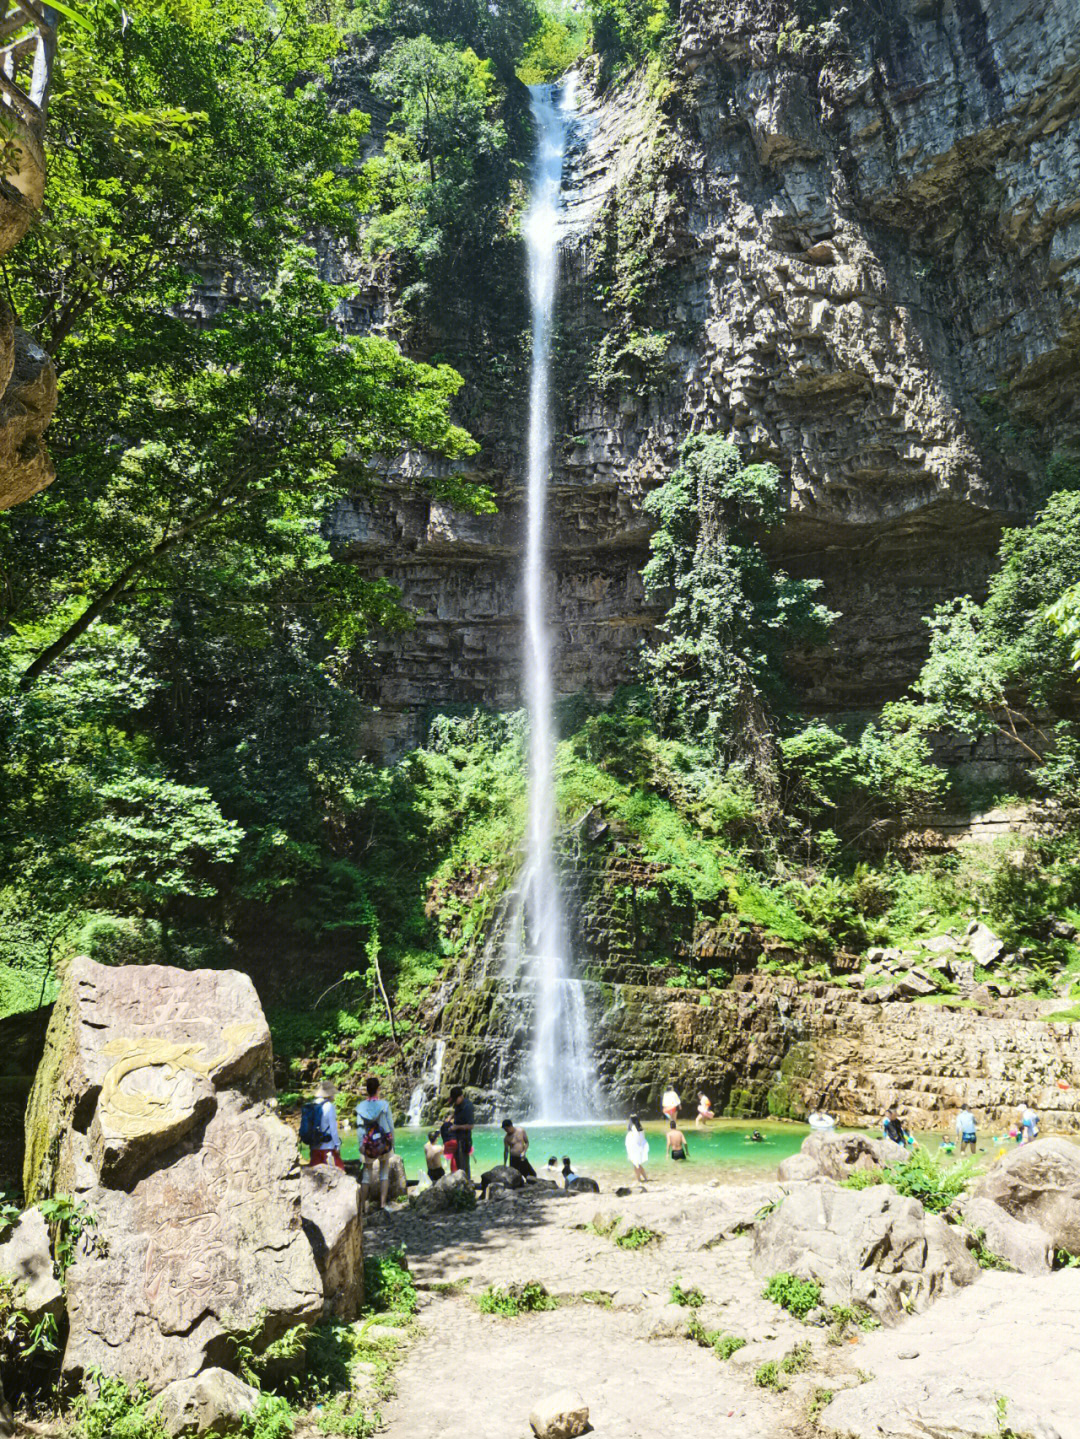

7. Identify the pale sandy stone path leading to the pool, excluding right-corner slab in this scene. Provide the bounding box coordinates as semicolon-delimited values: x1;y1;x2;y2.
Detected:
368;1184;859;1439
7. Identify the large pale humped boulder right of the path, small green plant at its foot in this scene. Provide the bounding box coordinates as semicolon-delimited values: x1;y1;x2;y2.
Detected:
752;1180;981;1324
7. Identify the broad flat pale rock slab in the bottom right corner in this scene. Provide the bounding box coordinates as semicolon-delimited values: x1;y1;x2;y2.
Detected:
818;1269;1080;1439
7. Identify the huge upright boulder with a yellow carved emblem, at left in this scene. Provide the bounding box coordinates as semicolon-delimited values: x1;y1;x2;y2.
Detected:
24;958;322;1393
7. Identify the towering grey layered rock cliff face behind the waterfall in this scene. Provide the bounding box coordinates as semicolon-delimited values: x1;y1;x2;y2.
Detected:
339;0;1080;745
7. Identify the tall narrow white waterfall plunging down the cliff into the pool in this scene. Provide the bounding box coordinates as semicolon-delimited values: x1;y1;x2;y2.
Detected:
508;76;595;1122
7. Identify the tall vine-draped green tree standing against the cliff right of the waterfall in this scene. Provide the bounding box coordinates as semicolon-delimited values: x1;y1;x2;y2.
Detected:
641;435;833;773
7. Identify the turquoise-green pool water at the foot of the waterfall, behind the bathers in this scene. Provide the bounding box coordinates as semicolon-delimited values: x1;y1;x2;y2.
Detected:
333;1120;810;1181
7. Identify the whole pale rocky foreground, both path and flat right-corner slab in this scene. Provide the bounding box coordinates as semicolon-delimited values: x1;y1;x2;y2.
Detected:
356;1181;1080;1439
